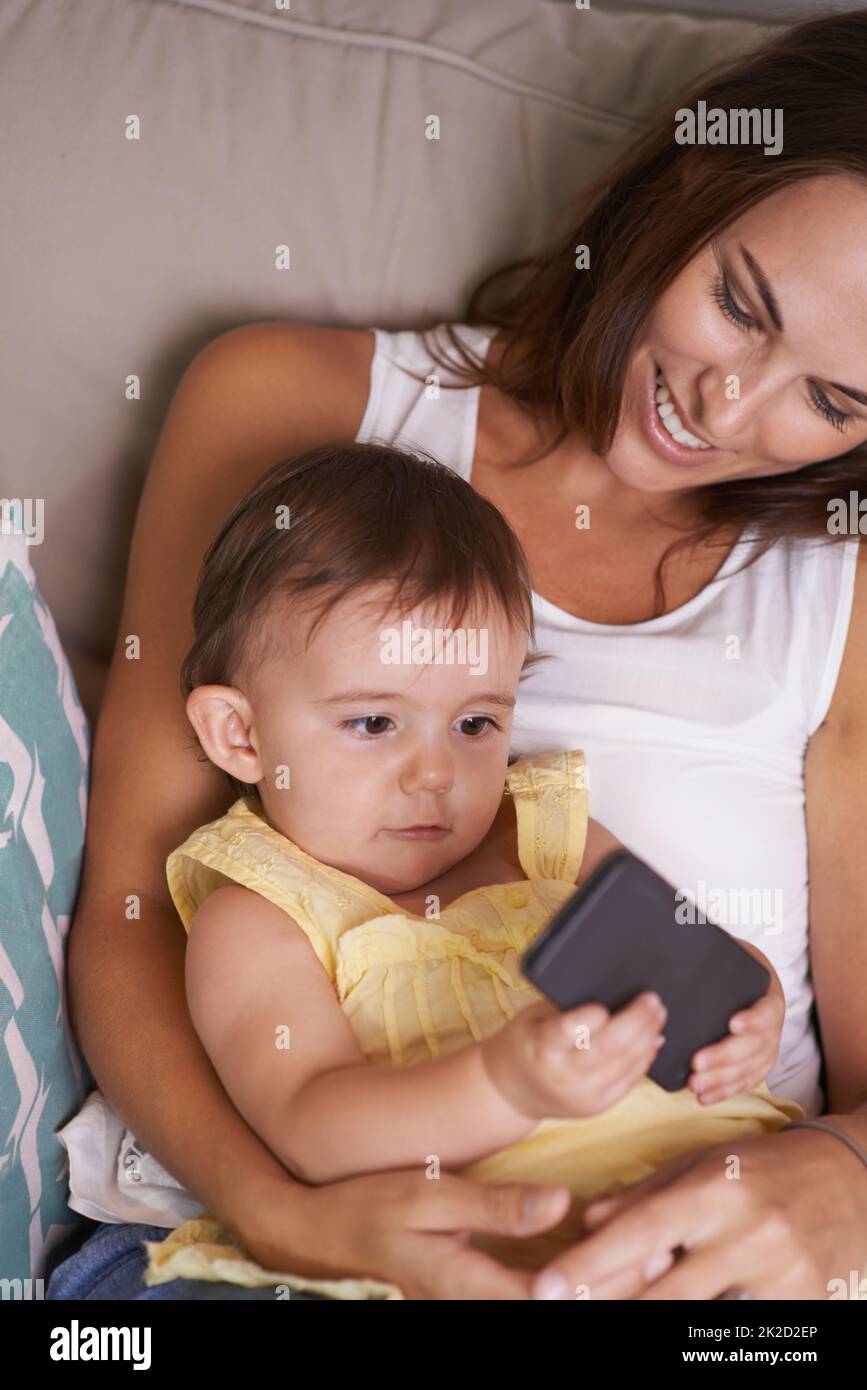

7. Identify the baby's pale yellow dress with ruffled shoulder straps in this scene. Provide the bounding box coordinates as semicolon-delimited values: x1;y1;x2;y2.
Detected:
145;751;804;1298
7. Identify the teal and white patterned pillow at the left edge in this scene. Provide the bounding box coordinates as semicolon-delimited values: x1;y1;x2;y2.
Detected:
0;521;94;1279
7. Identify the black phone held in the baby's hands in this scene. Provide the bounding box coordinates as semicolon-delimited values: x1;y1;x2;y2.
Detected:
521;849;771;1091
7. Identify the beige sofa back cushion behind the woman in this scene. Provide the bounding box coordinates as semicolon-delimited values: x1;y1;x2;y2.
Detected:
0;0;778;656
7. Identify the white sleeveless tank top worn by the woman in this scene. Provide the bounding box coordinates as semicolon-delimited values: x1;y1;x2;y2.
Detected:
357;324;857;1116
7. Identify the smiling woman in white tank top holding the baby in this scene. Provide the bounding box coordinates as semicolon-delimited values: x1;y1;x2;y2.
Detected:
57;11;867;1298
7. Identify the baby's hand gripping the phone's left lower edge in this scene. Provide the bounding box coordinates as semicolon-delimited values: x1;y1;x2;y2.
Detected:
479;995;666;1120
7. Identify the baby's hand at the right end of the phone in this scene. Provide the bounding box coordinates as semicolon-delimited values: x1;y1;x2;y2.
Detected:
686;941;785;1105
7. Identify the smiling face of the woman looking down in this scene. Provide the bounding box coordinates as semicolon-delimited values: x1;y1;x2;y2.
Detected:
606;175;867;493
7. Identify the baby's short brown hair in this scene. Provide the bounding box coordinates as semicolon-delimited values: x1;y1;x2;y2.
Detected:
181;443;546;796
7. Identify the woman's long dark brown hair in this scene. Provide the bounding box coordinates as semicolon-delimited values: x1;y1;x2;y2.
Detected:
407;10;867;614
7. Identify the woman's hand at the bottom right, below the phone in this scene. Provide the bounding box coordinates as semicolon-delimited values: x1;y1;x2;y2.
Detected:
534;1130;867;1300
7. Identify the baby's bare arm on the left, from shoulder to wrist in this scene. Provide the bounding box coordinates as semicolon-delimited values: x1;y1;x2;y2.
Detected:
186;885;535;1183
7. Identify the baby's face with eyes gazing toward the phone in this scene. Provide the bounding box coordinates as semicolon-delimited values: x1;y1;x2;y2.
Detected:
198;588;528;894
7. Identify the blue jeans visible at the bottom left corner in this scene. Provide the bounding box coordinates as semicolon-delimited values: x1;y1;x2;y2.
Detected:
46;1222;333;1302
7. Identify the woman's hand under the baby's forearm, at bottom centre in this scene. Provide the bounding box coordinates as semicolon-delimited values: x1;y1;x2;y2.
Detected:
238;1169;571;1300
